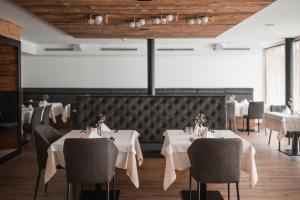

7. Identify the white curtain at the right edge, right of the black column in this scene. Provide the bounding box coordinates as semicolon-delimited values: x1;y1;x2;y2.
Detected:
293;41;300;112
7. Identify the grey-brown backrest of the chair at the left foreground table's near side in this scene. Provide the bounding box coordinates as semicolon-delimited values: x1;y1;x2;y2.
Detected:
64;138;118;183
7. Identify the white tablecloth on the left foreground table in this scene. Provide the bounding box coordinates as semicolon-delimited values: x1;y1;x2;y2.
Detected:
44;130;143;188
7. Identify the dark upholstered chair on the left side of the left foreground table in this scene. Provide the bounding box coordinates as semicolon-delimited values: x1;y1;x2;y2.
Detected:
33;125;61;200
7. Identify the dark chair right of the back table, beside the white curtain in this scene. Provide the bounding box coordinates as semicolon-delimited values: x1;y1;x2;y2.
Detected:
243;101;264;135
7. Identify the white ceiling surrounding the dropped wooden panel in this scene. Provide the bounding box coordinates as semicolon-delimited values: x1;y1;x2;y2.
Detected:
0;0;300;48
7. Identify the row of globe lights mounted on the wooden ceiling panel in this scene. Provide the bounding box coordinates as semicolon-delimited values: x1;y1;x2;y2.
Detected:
87;14;209;28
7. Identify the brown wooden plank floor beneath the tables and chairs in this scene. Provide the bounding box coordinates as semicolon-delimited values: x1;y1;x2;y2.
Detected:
0;132;300;200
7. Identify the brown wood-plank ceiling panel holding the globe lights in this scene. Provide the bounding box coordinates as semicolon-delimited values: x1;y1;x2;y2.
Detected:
13;0;275;38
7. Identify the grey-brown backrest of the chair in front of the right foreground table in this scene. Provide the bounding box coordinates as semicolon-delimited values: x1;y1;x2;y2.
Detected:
188;138;243;183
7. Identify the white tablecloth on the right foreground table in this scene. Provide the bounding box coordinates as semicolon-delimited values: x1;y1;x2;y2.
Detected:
161;130;258;190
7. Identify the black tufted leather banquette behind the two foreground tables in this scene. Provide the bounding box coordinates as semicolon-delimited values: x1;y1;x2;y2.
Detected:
75;96;226;148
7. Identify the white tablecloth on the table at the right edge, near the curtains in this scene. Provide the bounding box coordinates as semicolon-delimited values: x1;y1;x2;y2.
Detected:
263;112;300;140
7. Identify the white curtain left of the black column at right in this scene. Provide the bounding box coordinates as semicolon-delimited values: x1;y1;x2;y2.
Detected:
265;45;286;105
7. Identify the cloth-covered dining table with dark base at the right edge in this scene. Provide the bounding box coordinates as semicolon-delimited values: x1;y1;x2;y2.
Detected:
262;112;300;156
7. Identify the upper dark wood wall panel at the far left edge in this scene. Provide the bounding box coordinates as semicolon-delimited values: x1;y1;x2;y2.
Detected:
0;42;18;91
